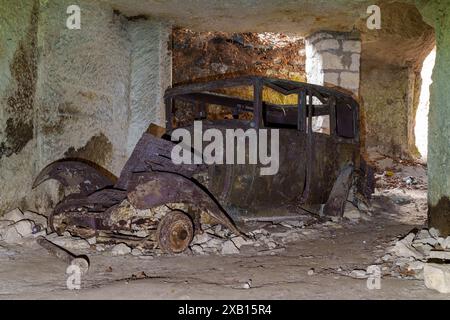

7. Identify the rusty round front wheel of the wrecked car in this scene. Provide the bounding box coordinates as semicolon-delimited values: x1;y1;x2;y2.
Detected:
156;210;194;253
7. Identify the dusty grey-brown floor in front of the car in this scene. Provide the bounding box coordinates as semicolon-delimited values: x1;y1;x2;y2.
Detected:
0;161;450;299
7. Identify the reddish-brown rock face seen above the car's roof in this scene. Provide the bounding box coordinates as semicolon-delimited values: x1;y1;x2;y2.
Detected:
173;28;305;84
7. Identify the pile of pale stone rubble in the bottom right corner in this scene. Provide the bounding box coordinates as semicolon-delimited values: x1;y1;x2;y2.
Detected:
376;228;450;293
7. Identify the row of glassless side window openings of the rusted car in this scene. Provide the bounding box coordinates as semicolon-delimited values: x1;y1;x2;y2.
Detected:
163;79;357;139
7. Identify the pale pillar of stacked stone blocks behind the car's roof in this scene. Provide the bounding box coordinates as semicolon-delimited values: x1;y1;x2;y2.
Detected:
305;32;361;96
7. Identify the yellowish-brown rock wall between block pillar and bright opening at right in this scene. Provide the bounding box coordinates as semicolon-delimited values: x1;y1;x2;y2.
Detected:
357;2;434;159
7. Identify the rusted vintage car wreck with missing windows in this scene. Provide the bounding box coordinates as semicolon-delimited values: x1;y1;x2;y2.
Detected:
34;76;373;253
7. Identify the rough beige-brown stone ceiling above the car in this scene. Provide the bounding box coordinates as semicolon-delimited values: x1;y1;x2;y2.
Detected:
103;0;434;68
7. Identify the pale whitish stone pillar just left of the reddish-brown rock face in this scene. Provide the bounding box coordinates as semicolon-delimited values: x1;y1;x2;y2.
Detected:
127;19;172;155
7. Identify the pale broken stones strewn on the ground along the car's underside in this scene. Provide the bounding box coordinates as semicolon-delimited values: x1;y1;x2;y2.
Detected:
0;208;365;258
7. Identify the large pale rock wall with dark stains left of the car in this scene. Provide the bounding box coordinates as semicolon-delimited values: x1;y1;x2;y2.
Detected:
0;0;171;215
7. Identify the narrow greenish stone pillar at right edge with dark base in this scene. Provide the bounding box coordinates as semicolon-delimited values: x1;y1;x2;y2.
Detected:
417;1;450;235
